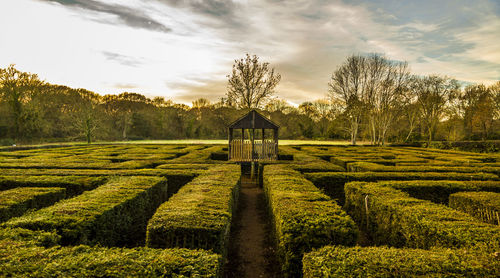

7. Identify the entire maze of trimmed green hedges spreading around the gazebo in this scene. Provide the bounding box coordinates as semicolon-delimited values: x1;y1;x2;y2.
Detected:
0;143;500;277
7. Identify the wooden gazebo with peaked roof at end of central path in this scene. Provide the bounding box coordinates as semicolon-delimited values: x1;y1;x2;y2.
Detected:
228;110;279;162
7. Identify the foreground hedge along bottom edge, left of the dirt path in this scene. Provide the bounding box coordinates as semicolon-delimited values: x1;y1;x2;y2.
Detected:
0;244;221;277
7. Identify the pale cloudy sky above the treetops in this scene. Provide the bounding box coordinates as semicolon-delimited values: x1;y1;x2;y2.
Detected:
0;0;500;105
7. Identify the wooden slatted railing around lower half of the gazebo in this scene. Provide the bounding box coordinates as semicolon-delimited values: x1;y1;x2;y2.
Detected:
230;139;277;161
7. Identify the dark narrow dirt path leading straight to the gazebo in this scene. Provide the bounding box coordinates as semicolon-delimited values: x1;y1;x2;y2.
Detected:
224;170;281;278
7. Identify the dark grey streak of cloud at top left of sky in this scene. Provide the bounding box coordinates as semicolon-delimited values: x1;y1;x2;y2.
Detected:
40;0;171;32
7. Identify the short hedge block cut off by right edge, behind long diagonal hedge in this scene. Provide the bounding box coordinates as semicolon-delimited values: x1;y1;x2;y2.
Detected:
449;191;500;225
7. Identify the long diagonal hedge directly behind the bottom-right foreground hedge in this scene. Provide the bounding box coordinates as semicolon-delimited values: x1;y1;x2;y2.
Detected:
344;182;500;251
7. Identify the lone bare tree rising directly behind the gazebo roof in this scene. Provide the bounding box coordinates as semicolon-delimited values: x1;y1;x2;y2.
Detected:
227;54;281;109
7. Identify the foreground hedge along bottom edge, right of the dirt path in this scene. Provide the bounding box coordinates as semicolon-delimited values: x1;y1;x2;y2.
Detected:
303;246;500;278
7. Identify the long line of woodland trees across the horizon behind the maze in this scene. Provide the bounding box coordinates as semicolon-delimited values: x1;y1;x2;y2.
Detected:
0;62;500;145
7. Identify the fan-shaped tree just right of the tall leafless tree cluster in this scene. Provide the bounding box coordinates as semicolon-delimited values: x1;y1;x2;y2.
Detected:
410;75;460;144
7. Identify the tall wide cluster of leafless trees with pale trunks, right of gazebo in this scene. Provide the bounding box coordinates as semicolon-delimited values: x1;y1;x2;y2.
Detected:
328;54;410;144
